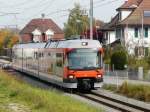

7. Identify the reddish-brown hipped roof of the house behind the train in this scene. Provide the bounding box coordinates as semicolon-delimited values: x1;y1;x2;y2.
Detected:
20;19;63;34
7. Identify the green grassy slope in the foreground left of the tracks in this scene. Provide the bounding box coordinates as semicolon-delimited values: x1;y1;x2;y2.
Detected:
0;71;101;112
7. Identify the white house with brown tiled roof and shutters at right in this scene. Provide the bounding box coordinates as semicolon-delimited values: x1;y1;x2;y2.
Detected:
102;0;150;56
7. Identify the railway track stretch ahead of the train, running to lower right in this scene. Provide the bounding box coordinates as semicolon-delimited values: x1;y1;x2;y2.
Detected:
77;91;150;112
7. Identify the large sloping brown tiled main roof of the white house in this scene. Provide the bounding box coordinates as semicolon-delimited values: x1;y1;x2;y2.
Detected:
118;0;150;25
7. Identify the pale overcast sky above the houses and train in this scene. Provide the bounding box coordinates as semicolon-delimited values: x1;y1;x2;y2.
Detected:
0;0;125;28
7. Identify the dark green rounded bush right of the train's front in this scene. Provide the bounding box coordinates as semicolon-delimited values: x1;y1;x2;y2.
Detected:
111;50;127;70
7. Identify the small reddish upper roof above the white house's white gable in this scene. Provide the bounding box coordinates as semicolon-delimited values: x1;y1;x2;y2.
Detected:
117;0;143;10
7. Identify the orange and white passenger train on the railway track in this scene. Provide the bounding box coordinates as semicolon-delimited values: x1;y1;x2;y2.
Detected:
12;39;104;89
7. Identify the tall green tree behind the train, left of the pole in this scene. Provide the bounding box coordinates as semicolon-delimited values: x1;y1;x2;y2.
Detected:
64;4;89;38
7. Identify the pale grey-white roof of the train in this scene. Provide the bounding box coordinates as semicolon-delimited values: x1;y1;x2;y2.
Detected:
13;39;102;48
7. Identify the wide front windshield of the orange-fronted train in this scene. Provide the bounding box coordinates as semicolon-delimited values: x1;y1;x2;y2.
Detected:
68;49;101;70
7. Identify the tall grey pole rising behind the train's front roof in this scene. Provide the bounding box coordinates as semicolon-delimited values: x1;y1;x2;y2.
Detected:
90;0;93;39
